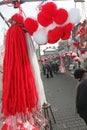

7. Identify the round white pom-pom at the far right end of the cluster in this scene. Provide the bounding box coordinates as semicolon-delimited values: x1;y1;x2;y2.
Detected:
68;8;81;24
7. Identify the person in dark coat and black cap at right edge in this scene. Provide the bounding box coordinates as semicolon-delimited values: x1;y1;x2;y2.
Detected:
74;68;87;125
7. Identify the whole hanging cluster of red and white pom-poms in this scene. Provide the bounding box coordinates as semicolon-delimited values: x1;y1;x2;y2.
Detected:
24;1;81;45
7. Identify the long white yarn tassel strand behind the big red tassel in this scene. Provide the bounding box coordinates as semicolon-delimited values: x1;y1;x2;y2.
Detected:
26;33;47;107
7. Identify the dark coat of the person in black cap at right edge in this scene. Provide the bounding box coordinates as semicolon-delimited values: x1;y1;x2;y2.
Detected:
76;79;87;120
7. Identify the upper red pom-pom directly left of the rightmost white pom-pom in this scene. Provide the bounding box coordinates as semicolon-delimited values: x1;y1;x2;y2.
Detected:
54;8;68;24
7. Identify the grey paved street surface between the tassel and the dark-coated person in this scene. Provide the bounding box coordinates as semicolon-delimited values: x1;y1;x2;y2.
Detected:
0;73;87;130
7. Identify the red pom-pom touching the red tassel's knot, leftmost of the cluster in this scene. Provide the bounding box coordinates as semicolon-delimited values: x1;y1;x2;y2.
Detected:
24;18;39;35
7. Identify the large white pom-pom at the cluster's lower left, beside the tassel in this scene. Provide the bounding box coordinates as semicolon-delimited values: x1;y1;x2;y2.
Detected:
33;28;48;45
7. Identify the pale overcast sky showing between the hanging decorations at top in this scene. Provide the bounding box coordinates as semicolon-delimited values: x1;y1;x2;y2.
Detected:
0;0;87;52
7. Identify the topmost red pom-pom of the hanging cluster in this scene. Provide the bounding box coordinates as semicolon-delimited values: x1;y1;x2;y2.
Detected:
41;2;57;17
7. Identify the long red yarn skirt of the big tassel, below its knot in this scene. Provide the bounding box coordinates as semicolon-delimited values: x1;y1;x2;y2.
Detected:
2;25;38;115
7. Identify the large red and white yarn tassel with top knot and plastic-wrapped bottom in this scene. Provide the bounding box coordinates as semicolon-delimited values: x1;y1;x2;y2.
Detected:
1;2;49;130
